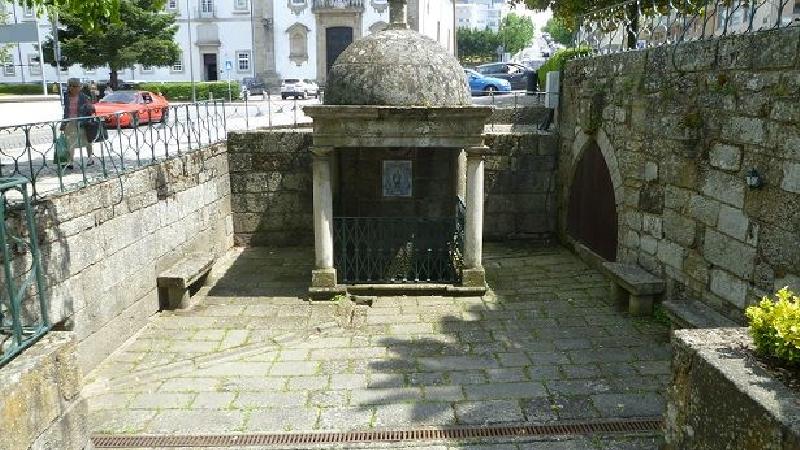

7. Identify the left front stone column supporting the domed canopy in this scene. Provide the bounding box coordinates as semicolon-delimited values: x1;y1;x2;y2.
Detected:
311;147;336;287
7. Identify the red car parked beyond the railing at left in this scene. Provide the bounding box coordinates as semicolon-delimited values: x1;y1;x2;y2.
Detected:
94;91;169;128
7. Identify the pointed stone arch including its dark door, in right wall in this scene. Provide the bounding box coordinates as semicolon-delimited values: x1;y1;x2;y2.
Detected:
563;130;623;260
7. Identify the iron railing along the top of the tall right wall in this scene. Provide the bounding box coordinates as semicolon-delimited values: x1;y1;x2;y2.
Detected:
575;0;800;53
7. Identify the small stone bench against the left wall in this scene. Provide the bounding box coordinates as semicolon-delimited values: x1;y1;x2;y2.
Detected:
157;253;214;309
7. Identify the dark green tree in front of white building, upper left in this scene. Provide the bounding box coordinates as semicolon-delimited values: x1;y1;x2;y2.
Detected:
44;0;180;88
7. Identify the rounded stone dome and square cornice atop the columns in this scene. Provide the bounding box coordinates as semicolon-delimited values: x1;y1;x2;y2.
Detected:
304;23;492;148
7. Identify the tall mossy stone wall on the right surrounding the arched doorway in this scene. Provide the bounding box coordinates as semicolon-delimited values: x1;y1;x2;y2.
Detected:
558;27;800;320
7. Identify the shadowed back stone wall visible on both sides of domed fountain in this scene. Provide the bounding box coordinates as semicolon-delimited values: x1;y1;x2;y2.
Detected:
228;126;558;246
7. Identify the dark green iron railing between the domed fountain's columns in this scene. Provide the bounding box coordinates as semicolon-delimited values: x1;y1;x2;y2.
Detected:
333;203;464;284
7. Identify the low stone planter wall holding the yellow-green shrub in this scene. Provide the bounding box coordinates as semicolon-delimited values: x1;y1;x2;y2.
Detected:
665;328;800;450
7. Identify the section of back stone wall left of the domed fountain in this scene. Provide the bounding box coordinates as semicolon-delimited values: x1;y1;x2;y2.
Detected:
228;130;314;246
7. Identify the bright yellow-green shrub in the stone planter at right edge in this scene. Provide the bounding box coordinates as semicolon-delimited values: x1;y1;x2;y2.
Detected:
745;288;800;366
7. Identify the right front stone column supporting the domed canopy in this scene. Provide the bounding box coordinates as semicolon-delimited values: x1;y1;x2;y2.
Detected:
463;147;488;287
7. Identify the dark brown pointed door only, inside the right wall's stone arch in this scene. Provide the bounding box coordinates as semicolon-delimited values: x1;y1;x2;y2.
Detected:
567;142;618;261
